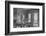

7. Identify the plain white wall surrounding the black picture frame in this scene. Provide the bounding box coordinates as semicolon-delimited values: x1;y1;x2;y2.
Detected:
0;0;46;36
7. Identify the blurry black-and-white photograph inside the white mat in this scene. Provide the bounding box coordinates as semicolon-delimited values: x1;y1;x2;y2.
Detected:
13;8;39;28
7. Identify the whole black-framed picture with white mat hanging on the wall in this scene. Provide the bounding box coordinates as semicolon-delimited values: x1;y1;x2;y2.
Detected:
5;1;45;35
